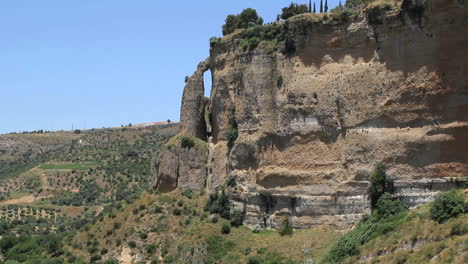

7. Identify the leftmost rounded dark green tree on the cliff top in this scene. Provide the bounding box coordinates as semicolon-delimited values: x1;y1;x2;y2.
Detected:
223;8;263;36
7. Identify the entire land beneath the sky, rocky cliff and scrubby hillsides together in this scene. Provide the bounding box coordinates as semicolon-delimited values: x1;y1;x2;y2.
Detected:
0;0;468;264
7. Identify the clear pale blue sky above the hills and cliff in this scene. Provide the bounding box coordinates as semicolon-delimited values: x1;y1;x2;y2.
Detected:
0;0;338;133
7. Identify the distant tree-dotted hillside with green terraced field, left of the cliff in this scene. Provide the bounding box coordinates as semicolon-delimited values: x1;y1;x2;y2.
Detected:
0;124;178;206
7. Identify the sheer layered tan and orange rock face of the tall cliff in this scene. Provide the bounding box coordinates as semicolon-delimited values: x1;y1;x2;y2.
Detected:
154;0;468;227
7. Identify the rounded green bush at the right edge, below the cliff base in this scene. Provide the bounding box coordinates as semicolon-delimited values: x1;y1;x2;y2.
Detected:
430;190;467;223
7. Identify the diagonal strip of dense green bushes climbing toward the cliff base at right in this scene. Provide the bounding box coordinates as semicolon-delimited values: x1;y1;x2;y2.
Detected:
321;194;407;263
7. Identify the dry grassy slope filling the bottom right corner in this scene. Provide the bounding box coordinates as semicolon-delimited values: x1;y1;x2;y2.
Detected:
347;192;468;263
